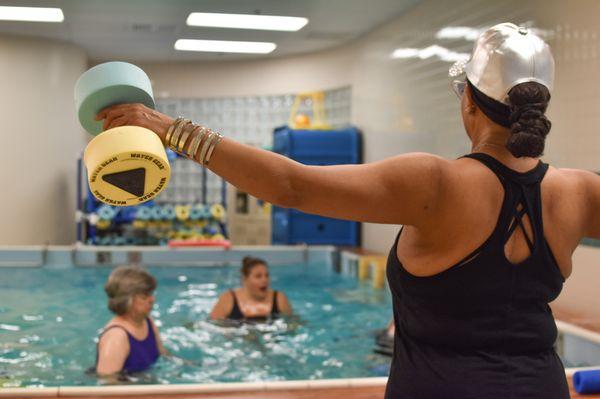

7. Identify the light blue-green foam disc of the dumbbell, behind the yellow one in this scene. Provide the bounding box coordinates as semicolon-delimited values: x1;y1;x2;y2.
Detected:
75;61;155;135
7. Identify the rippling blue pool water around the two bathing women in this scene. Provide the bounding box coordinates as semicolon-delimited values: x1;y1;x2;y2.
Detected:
0;265;391;387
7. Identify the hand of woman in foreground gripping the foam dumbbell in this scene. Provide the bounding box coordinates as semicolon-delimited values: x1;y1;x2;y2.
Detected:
96;104;175;144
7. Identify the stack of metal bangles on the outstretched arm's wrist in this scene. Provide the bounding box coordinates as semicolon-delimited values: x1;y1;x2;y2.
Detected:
165;118;223;165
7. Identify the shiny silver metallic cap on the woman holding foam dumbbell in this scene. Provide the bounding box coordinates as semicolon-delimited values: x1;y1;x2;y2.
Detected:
449;23;554;105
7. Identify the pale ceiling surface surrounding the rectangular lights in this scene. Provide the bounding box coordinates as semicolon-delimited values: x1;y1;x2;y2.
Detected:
0;0;418;62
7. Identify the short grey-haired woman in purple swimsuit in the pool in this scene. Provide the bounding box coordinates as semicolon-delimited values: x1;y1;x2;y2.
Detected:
96;266;167;375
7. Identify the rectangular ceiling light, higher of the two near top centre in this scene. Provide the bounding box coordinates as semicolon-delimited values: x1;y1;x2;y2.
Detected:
186;12;308;32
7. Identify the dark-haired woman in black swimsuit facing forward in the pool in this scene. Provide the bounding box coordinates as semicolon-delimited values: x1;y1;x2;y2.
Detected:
210;256;292;322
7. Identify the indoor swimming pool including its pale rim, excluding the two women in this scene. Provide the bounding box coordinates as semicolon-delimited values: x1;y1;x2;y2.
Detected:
0;246;600;397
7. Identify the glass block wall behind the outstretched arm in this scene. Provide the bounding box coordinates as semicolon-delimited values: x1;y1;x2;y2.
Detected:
156;87;352;204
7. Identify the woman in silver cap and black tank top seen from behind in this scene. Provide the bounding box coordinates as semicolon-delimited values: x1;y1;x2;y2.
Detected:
99;24;600;399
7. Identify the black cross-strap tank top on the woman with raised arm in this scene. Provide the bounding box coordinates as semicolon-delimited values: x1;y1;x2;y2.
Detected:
386;153;569;399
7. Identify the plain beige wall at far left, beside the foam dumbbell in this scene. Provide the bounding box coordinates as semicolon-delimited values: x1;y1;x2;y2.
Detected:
0;36;87;245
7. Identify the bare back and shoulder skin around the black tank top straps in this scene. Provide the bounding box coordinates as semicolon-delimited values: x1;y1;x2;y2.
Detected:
397;158;589;278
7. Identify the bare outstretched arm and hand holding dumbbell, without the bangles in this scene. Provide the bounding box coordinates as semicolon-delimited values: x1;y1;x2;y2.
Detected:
98;104;449;225
